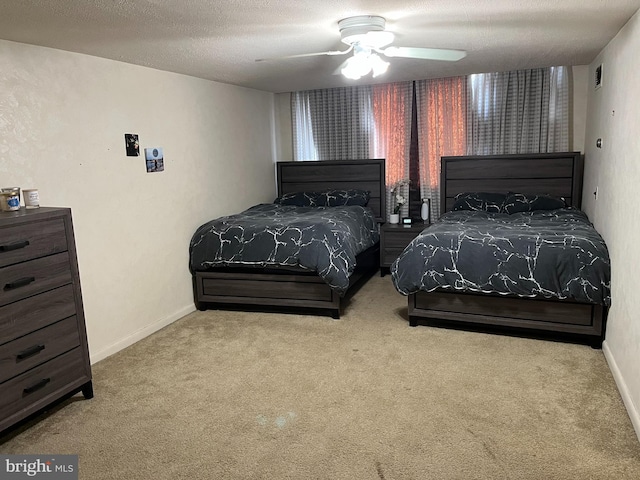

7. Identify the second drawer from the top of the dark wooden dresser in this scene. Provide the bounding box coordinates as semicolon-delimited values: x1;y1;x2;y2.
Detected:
0;252;71;305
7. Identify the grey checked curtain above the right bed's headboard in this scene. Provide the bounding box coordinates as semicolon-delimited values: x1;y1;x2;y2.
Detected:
467;67;569;155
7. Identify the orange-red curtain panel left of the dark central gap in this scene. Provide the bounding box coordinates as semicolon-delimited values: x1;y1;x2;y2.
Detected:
372;82;413;218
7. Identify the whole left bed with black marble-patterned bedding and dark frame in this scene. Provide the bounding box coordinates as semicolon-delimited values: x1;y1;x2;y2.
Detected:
189;159;385;319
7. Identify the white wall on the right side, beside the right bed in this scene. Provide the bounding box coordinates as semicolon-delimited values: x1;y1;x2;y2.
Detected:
583;12;640;437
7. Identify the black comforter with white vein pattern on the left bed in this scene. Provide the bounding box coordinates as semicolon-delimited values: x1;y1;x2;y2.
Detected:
189;204;380;295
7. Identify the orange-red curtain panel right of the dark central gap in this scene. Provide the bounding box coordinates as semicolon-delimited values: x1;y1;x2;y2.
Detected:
416;77;467;220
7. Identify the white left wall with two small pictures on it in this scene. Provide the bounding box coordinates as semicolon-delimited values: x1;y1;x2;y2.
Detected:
0;41;275;362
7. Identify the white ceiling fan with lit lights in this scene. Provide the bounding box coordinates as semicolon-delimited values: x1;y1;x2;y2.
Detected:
256;15;467;80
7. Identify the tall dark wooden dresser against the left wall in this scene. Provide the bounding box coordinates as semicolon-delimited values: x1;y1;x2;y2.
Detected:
0;207;93;432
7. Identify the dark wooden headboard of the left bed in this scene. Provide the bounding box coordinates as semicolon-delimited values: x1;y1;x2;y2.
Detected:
276;159;386;222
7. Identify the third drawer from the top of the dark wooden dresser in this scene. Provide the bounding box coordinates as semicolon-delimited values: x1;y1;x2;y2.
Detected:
0;285;76;345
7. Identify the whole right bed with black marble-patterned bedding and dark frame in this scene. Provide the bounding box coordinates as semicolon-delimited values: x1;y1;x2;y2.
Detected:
391;152;611;348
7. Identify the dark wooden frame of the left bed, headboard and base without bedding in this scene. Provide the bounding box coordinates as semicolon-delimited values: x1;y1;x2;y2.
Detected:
193;159;385;319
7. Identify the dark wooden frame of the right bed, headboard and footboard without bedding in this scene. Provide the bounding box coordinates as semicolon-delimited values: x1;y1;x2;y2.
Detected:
408;152;607;348
